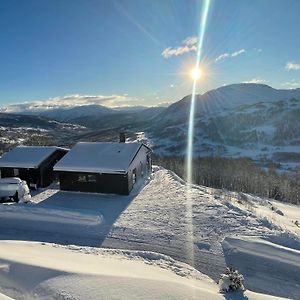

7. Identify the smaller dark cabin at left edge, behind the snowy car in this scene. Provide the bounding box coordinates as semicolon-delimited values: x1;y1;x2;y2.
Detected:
0;146;68;188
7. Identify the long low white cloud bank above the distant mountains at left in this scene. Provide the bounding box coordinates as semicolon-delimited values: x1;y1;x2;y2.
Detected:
1;94;144;113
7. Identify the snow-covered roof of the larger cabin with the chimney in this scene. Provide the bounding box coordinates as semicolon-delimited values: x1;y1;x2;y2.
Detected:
54;142;149;174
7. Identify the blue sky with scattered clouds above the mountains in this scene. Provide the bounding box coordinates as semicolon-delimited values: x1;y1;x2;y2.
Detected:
0;0;300;107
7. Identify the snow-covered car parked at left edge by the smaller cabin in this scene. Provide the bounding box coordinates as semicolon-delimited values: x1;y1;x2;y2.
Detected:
0;177;31;202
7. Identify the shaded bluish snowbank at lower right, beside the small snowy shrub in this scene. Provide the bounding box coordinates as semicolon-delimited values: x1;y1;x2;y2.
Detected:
223;237;300;299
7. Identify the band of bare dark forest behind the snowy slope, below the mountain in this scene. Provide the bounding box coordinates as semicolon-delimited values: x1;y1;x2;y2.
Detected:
153;156;300;204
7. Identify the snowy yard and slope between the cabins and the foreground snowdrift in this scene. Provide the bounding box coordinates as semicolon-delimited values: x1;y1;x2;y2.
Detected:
0;168;300;299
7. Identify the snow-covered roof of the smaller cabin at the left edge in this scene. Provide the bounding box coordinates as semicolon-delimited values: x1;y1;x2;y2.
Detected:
0;146;67;169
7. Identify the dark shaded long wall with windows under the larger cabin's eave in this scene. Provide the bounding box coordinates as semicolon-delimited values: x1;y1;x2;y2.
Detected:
58;171;129;195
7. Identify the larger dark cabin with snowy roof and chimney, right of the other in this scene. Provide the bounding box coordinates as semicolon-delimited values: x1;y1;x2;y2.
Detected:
54;142;152;195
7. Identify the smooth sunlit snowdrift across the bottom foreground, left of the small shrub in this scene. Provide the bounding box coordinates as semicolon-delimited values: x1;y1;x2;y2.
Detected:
0;241;282;300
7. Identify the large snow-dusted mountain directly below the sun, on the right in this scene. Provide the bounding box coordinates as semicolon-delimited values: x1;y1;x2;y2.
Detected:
146;84;300;169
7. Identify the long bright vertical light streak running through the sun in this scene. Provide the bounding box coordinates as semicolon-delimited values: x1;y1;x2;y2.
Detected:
186;0;211;274
